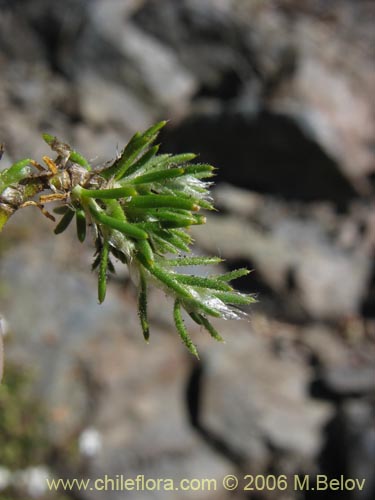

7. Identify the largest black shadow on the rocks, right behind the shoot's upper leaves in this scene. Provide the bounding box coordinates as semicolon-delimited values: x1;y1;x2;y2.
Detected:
162;111;357;208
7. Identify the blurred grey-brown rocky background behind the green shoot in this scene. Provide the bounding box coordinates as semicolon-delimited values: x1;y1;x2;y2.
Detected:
0;0;375;500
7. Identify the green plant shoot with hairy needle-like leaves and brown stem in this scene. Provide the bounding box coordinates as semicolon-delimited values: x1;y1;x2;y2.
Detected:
0;122;255;357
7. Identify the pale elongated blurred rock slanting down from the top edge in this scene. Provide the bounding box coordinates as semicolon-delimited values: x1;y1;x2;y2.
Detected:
77;1;195;113
